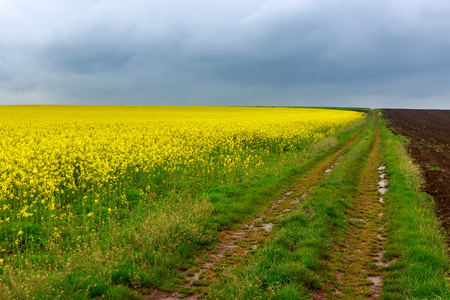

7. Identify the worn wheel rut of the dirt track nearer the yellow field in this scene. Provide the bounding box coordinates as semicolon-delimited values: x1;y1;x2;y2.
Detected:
144;118;368;300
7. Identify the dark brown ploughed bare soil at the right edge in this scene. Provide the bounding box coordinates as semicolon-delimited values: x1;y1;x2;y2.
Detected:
382;109;450;236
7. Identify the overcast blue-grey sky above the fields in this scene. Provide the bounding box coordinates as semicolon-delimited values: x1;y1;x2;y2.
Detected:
0;0;450;109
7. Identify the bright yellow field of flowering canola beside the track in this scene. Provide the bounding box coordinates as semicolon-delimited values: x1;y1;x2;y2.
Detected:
0;106;363;253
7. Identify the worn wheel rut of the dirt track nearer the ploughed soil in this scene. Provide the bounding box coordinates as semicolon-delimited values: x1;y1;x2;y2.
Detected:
322;118;393;300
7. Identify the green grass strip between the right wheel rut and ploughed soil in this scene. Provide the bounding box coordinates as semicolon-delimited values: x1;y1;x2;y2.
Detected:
381;114;450;299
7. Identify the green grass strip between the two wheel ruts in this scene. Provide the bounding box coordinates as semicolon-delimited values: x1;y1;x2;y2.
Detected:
207;112;374;299
